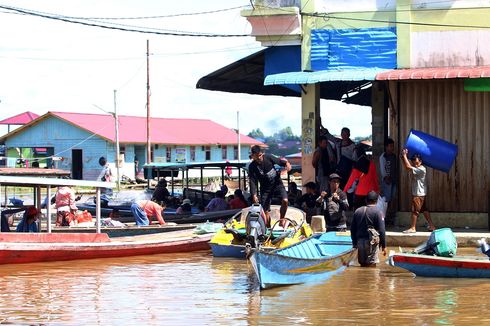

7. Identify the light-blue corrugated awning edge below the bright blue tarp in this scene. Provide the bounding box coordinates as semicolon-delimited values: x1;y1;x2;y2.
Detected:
264;68;389;86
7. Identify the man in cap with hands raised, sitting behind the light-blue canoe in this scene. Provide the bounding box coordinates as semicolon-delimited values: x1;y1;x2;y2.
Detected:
318;173;349;232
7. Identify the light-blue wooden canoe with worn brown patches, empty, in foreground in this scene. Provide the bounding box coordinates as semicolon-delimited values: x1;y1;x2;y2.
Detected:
250;232;355;289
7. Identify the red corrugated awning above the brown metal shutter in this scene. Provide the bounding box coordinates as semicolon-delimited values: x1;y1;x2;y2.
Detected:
376;66;490;80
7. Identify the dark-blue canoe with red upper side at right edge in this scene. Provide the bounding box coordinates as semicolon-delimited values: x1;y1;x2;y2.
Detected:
388;253;490;278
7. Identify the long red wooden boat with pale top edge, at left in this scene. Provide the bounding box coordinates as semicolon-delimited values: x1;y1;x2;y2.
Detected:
0;230;212;264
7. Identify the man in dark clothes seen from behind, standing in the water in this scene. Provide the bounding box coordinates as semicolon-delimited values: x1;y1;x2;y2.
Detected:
350;191;386;267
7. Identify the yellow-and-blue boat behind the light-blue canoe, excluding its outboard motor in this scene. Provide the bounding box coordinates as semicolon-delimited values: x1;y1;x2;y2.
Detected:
209;205;313;258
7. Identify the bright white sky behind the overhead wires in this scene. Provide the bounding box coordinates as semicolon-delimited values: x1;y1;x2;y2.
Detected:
0;0;371;137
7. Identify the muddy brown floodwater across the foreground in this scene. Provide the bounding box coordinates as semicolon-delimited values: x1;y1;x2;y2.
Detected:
0;249;490;325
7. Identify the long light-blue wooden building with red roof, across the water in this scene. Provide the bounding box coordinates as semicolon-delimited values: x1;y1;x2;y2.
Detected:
0;112;265;180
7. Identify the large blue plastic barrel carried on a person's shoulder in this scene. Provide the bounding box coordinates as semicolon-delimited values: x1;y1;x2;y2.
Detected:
405;129;458;173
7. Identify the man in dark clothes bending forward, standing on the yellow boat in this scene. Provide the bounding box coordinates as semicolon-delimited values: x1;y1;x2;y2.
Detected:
248;145;291;224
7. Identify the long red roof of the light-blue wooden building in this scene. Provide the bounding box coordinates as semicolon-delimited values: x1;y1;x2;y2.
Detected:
46;112;264;145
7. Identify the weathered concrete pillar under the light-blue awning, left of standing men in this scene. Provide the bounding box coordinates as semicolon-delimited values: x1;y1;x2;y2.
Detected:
301;84;320;184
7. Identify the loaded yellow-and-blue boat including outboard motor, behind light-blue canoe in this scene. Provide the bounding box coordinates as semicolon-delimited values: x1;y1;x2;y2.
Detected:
209;205;313;258
